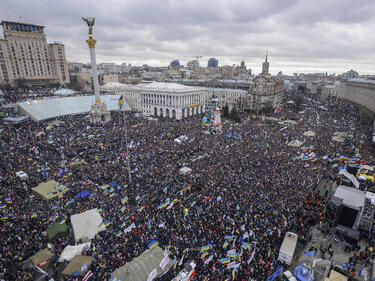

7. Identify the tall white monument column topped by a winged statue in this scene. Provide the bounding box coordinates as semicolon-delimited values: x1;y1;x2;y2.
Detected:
82;17;111;124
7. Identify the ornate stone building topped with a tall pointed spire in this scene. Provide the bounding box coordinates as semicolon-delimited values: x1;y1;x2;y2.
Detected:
250;55;284;112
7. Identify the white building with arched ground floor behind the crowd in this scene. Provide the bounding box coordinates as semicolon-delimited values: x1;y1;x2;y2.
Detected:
139;82;207;120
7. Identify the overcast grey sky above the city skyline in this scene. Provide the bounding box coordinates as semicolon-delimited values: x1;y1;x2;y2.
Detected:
0;0;375;74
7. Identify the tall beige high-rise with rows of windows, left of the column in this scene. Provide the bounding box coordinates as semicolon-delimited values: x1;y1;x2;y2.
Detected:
0;21;69;85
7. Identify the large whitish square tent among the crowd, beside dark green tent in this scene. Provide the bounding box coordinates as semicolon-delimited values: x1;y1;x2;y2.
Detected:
70;209;105;242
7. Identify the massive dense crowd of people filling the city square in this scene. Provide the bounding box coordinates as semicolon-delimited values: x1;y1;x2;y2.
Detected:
0;91;375;280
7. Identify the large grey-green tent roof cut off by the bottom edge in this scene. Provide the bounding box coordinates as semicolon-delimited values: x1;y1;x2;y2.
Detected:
112;246;171;281
